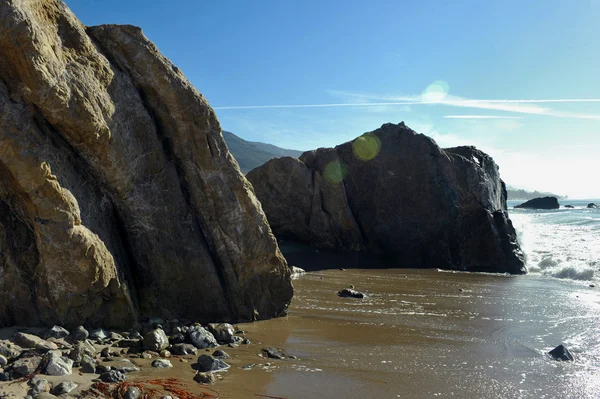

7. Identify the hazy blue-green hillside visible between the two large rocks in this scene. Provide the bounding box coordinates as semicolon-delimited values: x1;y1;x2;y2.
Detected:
223;130;303;173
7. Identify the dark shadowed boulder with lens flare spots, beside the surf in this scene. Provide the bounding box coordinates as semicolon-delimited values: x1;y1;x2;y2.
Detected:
247;123;525;273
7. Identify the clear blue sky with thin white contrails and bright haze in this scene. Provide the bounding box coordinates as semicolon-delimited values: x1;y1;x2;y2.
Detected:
66;0;600;198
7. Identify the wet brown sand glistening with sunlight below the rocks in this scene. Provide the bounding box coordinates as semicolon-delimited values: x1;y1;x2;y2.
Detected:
0;269;600;399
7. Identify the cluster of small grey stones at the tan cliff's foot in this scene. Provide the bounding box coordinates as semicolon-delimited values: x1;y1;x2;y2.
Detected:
0;319;255;399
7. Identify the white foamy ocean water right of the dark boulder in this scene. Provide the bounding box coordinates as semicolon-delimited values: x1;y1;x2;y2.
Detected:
508;199;600;284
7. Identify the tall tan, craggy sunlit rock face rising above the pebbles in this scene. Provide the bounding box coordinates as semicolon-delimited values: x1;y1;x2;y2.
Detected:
0;0;292;326
